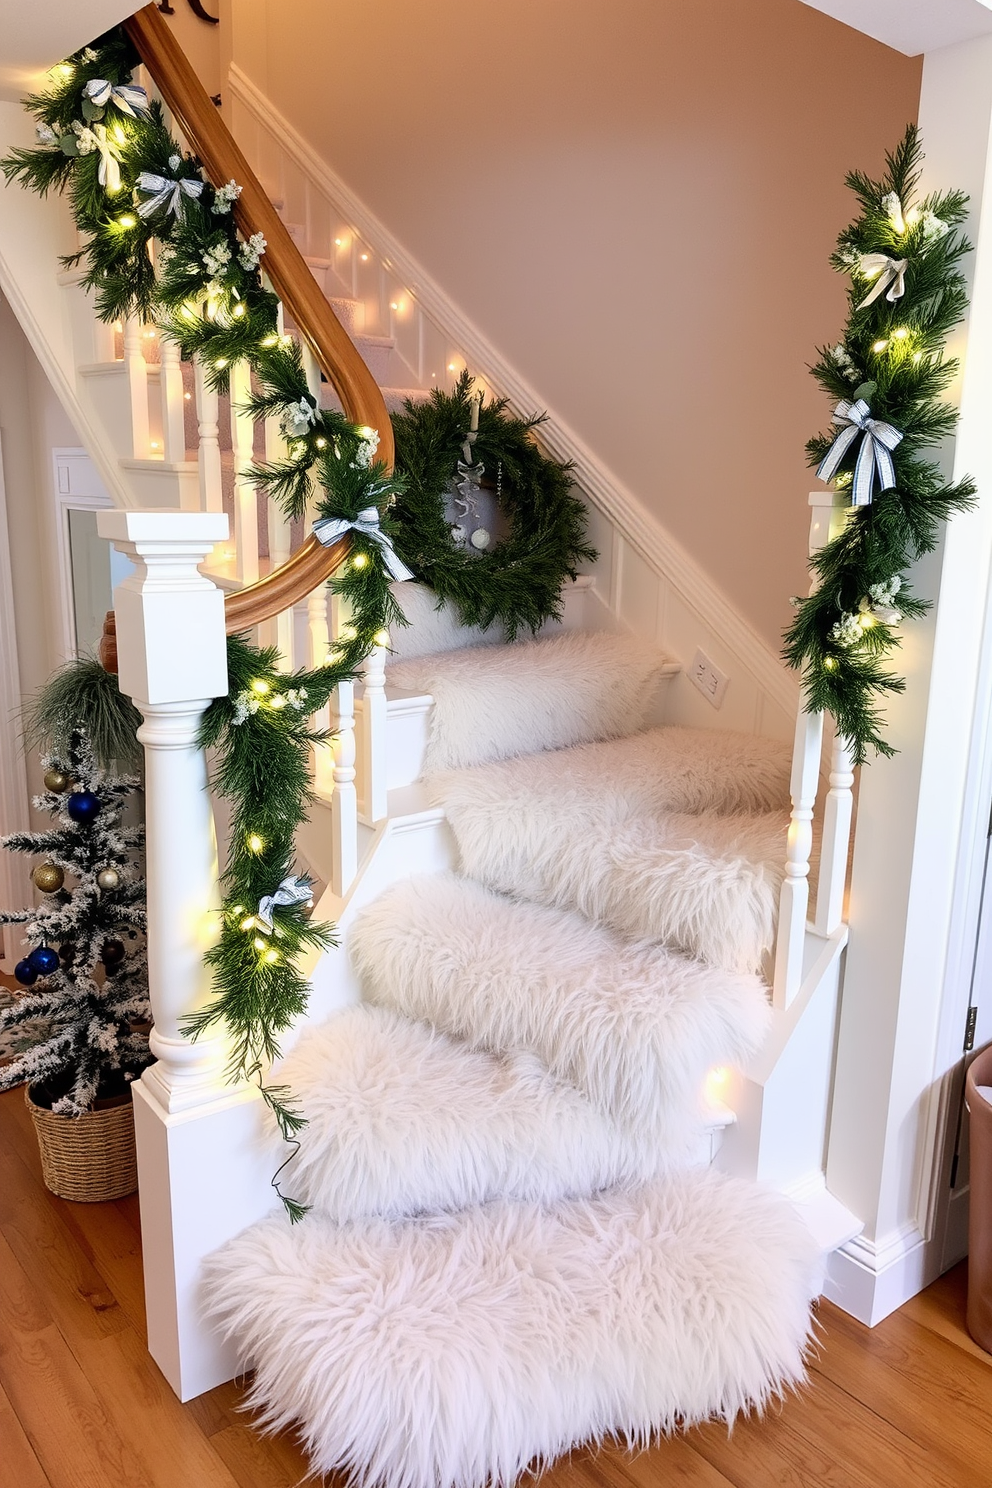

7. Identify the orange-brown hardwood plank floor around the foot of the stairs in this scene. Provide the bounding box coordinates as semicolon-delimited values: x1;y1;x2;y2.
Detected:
0;1091;992;1488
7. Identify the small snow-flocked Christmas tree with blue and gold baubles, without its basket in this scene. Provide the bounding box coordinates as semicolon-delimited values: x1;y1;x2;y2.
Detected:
0;734;150;1116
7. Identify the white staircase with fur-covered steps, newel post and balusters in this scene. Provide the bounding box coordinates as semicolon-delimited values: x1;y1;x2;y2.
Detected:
0;7;860;1440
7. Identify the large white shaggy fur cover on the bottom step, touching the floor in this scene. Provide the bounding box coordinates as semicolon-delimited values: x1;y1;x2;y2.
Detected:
204;1170;818;1488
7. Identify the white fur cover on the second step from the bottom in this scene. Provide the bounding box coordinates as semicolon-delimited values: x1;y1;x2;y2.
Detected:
278;1007;660;1223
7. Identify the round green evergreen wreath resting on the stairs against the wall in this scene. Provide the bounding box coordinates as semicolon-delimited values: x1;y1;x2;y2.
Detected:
390;372;596;640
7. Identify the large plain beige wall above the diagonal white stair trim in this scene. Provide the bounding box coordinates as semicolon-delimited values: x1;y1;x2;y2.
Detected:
222;0;921;647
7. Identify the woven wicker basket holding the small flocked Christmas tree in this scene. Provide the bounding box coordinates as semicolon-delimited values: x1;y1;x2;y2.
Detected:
24;1089;138;1204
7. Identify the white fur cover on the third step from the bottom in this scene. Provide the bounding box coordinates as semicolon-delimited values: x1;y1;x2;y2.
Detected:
349;873;770;1136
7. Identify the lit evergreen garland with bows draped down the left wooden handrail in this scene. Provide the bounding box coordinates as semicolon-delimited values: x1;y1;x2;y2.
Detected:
0;28;406;1219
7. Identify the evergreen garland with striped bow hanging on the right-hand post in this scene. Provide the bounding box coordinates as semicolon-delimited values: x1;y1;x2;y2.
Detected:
784;125;976;765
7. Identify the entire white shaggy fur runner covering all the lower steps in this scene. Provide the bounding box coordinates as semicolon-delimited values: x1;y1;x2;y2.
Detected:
207;635;817;1488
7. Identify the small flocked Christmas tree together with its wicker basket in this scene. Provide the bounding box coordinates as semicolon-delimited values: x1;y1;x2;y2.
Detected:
0;731;150;1201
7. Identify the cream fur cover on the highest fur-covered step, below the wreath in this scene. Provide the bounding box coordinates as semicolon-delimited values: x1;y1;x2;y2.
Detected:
388;631;668;771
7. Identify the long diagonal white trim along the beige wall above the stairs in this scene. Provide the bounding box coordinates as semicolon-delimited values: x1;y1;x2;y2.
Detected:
229;62;799;716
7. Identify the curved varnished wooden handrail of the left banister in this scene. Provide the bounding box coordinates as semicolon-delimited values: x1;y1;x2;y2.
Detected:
123;4;394;634
